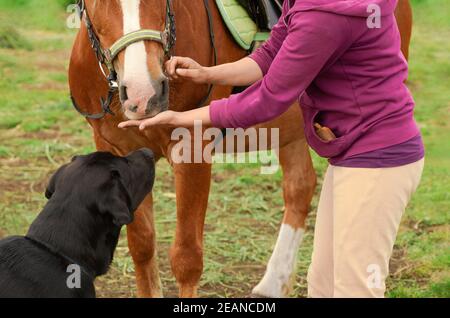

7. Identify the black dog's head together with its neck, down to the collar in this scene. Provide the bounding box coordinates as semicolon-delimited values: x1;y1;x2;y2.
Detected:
27;149;155;276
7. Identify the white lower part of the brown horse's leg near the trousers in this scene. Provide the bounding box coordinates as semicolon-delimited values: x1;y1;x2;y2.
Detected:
253;223;305;298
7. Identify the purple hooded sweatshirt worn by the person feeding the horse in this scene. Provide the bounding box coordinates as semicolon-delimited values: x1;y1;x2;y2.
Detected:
210;0;423;166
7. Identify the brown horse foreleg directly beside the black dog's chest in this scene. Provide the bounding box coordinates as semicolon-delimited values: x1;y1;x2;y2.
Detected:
127;194;163;298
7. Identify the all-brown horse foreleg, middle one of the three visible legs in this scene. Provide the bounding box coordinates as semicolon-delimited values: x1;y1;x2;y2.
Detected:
170;164;211;298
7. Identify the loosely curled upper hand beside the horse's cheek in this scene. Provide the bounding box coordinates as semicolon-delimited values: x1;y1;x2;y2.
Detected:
165;56;209;84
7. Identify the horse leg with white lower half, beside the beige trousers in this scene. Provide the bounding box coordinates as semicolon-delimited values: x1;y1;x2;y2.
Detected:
253;139;316;298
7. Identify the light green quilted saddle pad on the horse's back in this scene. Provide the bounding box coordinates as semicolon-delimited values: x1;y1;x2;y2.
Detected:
216;0;269;50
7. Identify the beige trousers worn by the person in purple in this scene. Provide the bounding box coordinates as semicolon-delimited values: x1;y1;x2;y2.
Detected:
308;160;424;298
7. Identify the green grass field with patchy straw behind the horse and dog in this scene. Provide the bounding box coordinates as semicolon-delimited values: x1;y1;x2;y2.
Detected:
0;0;450;297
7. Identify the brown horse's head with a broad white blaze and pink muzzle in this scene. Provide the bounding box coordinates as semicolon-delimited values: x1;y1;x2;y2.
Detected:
84;0;170;119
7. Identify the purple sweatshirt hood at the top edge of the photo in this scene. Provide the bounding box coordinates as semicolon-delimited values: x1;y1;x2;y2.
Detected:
286;0;398;18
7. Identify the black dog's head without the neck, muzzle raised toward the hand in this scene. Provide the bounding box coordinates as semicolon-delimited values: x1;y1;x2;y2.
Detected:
45;149;155;227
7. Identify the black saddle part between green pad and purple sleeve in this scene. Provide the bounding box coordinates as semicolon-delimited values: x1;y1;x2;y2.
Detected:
238;0;284;30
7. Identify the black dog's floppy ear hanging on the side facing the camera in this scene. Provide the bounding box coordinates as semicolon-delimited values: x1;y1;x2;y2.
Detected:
98;170;134;227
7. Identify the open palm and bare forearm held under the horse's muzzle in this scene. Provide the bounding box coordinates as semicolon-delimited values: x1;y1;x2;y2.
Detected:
119;106;211;130
